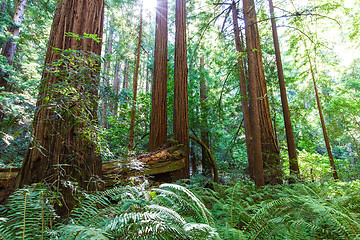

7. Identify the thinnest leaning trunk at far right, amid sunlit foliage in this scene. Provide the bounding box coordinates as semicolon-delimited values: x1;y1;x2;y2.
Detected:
307;55;339;180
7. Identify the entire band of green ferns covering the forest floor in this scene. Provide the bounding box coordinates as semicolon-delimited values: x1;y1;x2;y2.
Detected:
0;181;360;240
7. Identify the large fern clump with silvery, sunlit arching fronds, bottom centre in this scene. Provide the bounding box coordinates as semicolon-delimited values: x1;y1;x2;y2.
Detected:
58;184;219;240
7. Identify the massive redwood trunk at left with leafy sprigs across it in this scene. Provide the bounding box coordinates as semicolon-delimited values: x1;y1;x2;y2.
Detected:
16;0;104;215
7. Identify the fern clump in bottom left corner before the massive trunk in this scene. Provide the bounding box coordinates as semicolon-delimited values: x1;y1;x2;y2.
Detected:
0;184;57;240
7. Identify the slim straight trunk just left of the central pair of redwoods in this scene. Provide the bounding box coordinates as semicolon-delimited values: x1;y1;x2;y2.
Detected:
129;0;143;151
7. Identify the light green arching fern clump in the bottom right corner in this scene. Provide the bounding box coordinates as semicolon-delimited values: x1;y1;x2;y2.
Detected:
233;184;360;239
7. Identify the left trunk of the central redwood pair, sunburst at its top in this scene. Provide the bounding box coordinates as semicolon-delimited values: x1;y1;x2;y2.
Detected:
149;0;168;151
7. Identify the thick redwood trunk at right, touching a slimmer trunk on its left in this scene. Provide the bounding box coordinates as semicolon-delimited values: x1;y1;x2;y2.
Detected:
244;0;282;184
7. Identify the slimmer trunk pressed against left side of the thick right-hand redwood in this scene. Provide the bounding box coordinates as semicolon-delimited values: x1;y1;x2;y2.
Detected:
231;1;255;179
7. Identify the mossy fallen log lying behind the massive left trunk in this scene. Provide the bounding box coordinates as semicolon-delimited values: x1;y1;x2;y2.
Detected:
0;145;185;202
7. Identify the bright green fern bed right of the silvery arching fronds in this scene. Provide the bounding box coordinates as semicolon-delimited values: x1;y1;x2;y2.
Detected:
187;181;360;240
